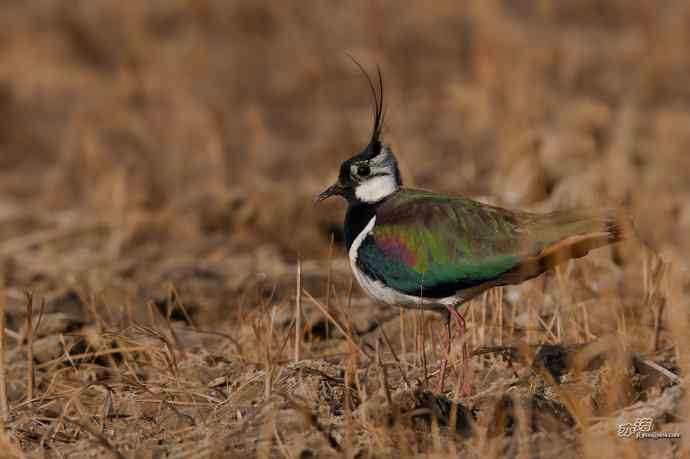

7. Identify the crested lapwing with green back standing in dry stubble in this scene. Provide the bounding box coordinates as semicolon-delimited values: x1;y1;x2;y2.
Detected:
315;63;624;395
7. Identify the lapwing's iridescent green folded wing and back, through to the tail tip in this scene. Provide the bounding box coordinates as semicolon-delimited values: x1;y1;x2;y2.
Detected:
357;189;620;298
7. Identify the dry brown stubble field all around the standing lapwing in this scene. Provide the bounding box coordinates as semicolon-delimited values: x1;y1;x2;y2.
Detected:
0;0;690;459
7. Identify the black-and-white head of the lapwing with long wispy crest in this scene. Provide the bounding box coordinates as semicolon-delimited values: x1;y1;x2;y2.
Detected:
316;61;402;204
